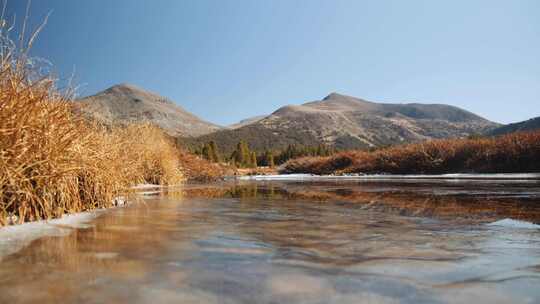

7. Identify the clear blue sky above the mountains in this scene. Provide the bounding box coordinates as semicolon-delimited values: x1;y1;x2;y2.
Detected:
8;0;540;125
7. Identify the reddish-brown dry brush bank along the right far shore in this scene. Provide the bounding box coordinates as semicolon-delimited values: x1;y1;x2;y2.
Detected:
281;131;540;174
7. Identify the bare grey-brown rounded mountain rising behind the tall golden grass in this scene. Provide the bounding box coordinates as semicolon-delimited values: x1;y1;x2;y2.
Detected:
75;84;221;136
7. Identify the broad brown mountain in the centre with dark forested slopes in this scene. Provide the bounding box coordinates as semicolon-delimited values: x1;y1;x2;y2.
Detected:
184;93;499;153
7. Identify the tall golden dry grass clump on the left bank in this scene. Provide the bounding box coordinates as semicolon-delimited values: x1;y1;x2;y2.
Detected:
0;17;183;226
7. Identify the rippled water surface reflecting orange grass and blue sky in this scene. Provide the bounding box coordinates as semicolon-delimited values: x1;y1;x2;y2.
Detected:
0;181;540;303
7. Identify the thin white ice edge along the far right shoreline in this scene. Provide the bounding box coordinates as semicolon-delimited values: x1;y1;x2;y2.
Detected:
238;173;540;181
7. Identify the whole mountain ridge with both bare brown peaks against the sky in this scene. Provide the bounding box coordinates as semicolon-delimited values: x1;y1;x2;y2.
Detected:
75;83;500;153
